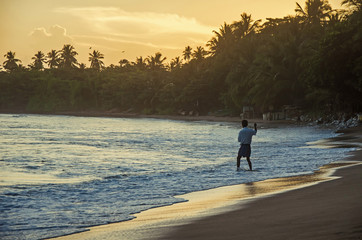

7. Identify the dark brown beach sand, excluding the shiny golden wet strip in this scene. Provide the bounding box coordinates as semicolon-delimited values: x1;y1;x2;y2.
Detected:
158;127;362;240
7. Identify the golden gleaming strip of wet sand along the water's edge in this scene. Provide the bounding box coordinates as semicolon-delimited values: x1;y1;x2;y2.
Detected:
49;161;362;240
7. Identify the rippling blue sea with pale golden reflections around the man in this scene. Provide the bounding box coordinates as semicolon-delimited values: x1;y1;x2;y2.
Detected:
0;114;349;240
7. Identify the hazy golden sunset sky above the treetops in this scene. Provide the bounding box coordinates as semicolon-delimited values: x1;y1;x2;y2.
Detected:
0;0;341;66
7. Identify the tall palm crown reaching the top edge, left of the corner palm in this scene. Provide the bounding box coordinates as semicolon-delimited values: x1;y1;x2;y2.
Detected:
295;0;332;24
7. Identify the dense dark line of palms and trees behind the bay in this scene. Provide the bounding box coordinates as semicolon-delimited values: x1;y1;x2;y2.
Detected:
0;0;362;114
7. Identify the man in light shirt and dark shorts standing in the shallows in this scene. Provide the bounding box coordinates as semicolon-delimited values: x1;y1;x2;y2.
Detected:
236;120;258;171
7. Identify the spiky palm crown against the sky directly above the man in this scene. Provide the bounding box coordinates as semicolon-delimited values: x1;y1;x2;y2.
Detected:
232;13;261;39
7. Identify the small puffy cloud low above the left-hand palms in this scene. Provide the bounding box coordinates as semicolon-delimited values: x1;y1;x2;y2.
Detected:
29;25;73;48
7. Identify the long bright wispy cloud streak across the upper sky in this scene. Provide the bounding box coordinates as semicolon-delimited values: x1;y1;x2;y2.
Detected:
55;7;213;38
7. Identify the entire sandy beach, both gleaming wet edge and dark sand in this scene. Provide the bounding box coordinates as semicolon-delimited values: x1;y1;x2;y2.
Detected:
52;127;362;240
